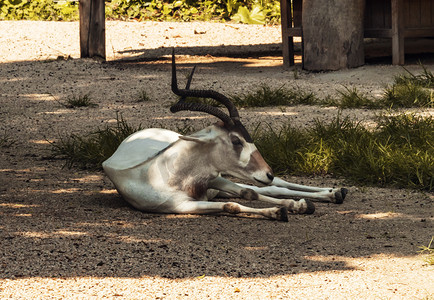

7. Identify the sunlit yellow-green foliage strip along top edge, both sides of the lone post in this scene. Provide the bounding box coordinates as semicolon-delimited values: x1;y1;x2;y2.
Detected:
0;0;280;24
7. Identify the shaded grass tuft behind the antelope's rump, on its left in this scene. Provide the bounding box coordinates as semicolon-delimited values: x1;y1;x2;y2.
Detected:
52;117;142;169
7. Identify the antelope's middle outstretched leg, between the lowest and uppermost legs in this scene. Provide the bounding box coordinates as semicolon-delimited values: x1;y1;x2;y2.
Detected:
209;177;315;214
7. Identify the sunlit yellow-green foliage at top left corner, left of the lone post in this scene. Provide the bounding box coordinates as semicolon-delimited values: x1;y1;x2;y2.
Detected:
0;0;78;21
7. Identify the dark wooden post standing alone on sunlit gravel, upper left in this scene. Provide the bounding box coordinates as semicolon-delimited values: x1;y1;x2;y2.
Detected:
79;0;106;60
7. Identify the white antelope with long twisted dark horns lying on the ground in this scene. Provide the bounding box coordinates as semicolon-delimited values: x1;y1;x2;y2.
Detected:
103;51;347;221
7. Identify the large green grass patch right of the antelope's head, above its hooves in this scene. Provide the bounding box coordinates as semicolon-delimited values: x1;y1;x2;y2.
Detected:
254;114;434;191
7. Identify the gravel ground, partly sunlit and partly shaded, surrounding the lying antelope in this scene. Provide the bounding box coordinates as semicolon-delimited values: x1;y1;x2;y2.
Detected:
0;22;434;299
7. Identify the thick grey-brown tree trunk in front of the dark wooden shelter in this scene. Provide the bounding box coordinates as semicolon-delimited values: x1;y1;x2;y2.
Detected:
302;0;365;71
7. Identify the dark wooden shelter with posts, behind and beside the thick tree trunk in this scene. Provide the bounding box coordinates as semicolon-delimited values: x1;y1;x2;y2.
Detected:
281;0;434;66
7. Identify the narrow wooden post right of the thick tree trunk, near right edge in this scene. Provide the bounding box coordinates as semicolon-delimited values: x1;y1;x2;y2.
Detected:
392;0;405;65
